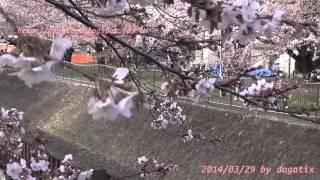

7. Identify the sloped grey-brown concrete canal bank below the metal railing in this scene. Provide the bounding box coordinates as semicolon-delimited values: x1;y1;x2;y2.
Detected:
0;74;320;180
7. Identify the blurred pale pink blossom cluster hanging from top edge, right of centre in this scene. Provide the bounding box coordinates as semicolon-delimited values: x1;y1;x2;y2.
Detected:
188;0;284;45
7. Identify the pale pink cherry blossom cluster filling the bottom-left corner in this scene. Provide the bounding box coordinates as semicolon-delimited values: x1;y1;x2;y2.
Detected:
0;108;93;180
